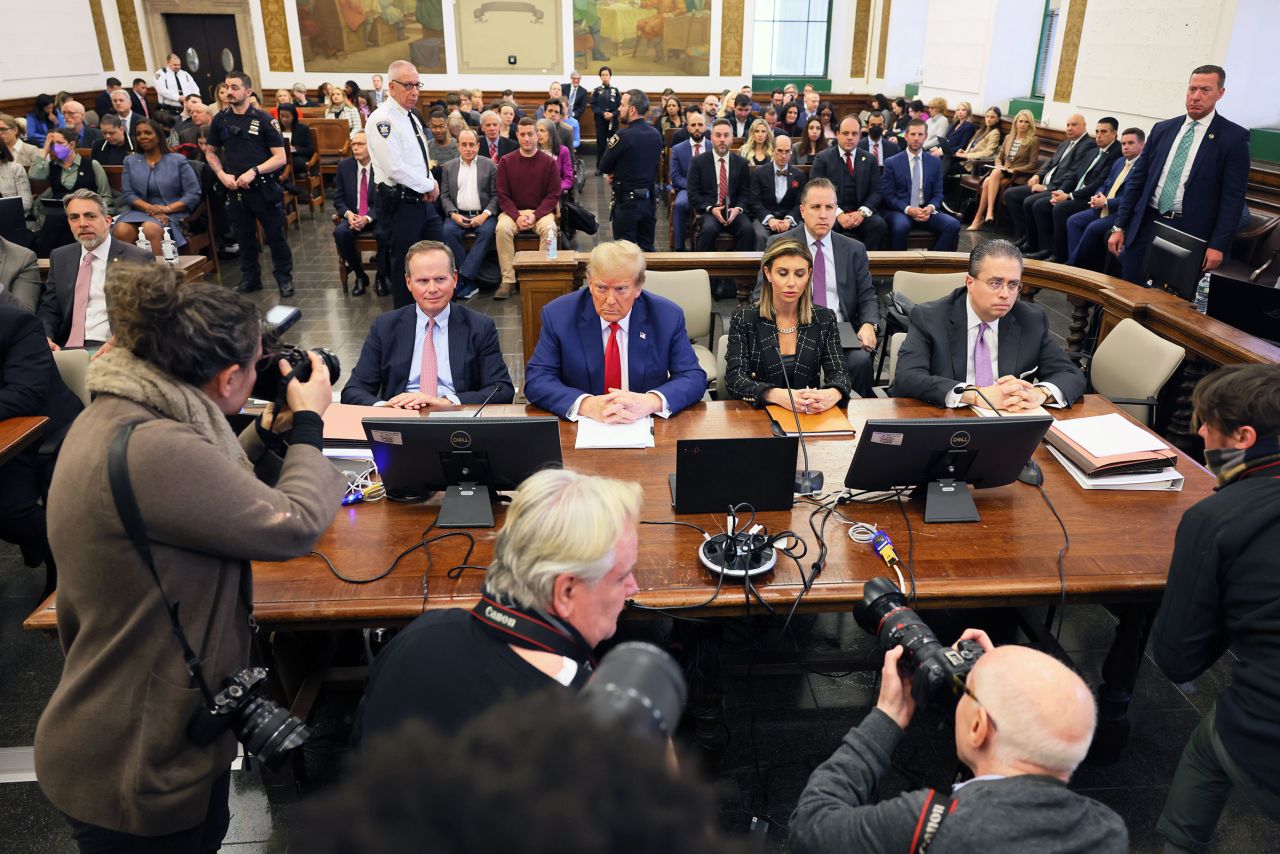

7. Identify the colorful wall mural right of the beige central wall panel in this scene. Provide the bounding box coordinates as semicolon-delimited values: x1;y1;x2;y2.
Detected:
573;0;713;77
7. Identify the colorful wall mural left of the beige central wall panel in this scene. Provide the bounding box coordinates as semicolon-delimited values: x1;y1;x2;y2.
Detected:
294;0;445;74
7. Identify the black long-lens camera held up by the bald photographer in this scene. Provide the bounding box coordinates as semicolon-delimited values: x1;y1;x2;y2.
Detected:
854;576;983;708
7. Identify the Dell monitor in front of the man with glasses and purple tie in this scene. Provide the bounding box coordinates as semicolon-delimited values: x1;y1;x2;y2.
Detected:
845;415;1053;522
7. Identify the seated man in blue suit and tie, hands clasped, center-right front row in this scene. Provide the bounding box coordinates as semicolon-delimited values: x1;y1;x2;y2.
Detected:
881;119;960;252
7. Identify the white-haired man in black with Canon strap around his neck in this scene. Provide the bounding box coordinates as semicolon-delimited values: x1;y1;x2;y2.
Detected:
355;469;641;743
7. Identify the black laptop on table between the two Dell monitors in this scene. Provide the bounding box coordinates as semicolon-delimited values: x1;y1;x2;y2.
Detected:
667;437;800;515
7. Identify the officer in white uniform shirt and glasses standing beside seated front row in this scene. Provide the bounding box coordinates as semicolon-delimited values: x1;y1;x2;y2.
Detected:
365;59;444;309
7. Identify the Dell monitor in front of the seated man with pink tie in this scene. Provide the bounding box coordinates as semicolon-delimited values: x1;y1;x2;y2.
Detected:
361;416;563;528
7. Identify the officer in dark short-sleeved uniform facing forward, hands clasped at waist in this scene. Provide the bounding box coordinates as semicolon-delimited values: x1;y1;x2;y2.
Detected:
209;72;293;297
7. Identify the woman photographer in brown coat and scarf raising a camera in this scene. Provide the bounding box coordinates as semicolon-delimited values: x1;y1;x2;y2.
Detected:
35;262;347;854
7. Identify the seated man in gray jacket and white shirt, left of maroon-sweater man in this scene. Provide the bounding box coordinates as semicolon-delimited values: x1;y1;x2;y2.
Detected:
440;128;498;300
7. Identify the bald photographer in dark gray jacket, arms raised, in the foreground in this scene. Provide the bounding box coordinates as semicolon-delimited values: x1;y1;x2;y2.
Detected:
788;629;1129;854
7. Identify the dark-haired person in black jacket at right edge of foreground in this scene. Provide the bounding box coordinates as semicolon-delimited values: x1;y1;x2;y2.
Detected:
1151;363;1280;854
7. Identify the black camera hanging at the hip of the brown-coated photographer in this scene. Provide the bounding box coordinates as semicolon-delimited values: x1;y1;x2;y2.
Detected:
187;667;311;771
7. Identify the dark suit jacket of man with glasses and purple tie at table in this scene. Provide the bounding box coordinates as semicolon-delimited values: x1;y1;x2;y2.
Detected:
890;287;1084;406
